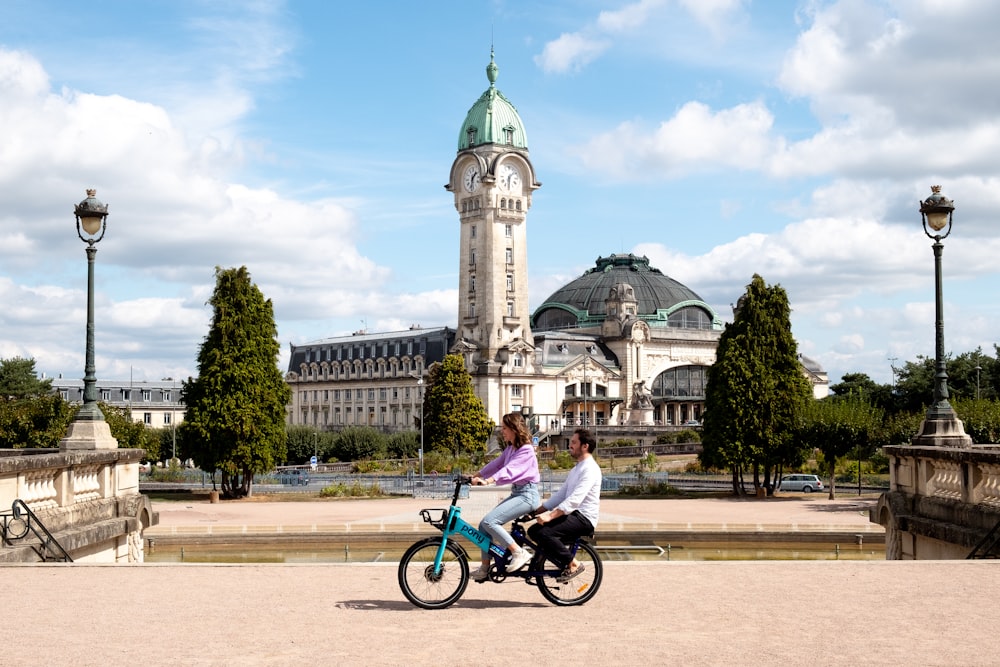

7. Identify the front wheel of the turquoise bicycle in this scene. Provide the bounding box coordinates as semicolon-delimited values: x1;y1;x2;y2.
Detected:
399;537;469;609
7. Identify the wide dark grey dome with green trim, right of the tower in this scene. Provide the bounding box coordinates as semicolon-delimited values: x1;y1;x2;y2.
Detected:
531;253;722;331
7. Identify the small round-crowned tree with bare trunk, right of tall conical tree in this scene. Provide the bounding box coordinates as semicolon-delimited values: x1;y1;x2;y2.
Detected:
798;394;884;500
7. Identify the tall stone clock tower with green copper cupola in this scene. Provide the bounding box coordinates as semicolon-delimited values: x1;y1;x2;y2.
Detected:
445;50;541;422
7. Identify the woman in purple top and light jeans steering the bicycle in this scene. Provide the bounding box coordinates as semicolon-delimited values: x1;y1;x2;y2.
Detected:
472;412;540;582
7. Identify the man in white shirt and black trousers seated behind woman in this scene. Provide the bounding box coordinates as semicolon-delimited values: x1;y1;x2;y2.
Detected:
528;428;602;583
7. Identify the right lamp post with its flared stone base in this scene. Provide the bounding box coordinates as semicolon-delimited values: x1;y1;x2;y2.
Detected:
912;185;972;447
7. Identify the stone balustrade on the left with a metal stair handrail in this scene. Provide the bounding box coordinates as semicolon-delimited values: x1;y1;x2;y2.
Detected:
0;449;156;562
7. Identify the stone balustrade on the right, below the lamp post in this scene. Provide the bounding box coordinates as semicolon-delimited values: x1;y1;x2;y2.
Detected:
871;445;1000;560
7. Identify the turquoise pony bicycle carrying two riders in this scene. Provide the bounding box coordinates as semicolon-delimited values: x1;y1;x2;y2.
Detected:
398;476;604;609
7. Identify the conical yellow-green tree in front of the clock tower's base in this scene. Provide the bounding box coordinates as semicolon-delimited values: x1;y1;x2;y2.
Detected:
424;354;495;460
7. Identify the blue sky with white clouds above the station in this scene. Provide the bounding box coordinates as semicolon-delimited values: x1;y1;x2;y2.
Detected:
0;0;1000;383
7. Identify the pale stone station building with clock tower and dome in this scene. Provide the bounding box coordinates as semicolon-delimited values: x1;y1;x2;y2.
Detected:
285;53;825;438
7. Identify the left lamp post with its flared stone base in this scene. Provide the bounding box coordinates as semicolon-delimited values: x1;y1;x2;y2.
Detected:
59;189;118;449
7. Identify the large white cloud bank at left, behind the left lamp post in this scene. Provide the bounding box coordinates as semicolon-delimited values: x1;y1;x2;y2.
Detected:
0;48;442;379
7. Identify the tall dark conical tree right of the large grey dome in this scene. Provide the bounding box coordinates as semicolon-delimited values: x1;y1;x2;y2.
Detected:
702;274;812;494
